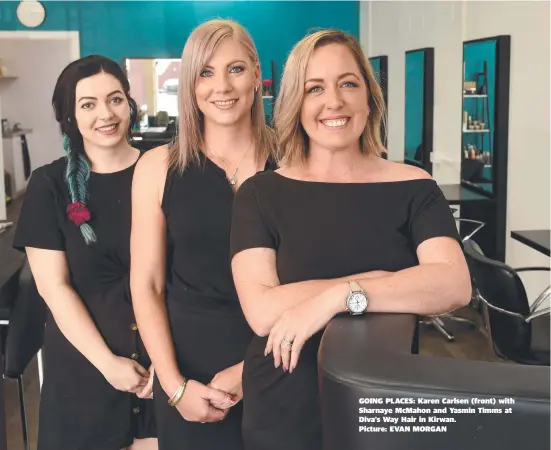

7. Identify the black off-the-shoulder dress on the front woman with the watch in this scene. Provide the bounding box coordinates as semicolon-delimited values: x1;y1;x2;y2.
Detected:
231;172;459;450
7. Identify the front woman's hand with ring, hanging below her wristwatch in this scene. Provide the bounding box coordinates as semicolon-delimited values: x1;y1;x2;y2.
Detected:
264;294;338;373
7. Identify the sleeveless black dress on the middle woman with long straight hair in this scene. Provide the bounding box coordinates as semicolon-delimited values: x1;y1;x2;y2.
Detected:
153;156;273;450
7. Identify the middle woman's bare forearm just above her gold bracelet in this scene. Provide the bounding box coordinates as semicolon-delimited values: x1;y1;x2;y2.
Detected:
132;283;182;395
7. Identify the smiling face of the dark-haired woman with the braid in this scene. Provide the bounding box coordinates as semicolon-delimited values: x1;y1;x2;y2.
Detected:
75;72;130;147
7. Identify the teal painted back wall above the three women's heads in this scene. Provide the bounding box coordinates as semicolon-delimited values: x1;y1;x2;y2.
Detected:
0;1;360;81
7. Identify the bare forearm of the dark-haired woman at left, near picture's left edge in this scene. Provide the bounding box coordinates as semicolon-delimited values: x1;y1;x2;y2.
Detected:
40;285;115;374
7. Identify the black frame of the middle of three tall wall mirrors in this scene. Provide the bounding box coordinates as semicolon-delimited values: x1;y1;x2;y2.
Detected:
403;47;434;175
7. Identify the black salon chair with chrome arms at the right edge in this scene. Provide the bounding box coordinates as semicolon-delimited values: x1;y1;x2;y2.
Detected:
464;241;550;366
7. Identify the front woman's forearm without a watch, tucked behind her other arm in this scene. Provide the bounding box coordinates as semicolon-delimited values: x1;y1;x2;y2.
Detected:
245;270;391;336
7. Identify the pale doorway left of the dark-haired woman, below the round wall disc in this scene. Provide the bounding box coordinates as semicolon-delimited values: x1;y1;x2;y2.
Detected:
0;31;80;220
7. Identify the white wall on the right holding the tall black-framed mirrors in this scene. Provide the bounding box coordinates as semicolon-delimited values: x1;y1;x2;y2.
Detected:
360;1;551;302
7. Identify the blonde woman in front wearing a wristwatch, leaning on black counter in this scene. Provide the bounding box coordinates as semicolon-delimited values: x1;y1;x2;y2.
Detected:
230;30;471;450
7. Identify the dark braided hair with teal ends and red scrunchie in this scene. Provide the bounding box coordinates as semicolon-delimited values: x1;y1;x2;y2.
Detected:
52;55;138;245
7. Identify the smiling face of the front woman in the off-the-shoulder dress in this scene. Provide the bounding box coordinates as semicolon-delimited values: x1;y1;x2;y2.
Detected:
300;43;369;151
